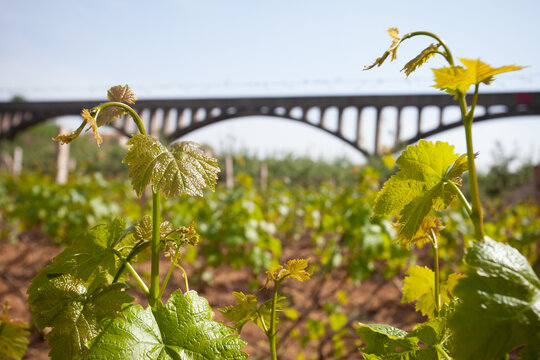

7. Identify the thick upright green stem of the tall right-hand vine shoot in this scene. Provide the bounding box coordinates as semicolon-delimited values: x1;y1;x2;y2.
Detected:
460;85;484;241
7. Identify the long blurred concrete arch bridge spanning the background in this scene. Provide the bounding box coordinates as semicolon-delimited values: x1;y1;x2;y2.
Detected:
0;92;540;157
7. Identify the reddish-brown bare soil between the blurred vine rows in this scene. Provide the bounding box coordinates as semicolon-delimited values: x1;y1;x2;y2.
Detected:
0;230;421;360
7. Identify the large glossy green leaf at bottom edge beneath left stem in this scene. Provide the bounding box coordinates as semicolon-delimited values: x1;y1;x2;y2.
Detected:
84;290;247;360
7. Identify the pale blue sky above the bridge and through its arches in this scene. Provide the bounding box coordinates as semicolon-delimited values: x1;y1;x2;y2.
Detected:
0;0;540;167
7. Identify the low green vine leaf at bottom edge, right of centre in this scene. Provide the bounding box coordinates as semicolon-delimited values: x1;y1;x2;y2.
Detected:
356;320;446;360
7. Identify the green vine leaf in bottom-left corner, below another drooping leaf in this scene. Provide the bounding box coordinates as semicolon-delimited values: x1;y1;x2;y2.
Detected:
29;275;133;360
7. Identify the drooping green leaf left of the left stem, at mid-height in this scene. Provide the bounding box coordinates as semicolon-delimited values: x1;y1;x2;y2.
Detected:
28;218;135;296
